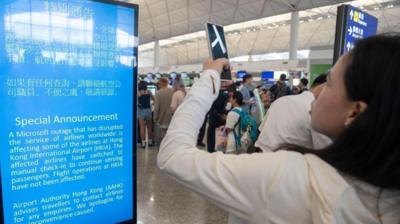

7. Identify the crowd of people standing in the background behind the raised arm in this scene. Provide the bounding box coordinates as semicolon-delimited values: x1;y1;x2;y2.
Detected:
138;67;316;153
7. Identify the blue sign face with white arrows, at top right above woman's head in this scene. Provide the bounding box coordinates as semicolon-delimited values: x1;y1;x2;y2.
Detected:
342;6;378;53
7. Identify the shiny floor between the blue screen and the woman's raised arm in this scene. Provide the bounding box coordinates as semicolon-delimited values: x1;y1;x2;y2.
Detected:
137;147;228;224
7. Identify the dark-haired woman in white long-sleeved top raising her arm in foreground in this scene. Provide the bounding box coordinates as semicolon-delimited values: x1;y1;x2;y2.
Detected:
158;34;400;224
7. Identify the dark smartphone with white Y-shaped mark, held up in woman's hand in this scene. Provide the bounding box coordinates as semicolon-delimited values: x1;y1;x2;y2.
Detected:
206;23;232;80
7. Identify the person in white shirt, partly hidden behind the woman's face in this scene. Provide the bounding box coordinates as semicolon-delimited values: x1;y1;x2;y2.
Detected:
255;74;332;152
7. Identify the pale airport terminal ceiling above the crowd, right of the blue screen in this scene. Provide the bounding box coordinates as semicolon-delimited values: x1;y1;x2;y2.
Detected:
122;0;400;67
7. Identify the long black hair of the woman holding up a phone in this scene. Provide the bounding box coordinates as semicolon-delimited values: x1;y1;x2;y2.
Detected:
288;34;400;190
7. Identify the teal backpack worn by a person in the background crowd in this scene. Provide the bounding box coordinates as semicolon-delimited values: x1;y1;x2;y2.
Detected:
232;108;258;151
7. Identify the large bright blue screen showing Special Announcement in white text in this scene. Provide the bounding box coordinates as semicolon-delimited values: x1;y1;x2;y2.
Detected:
0;0;138;224
